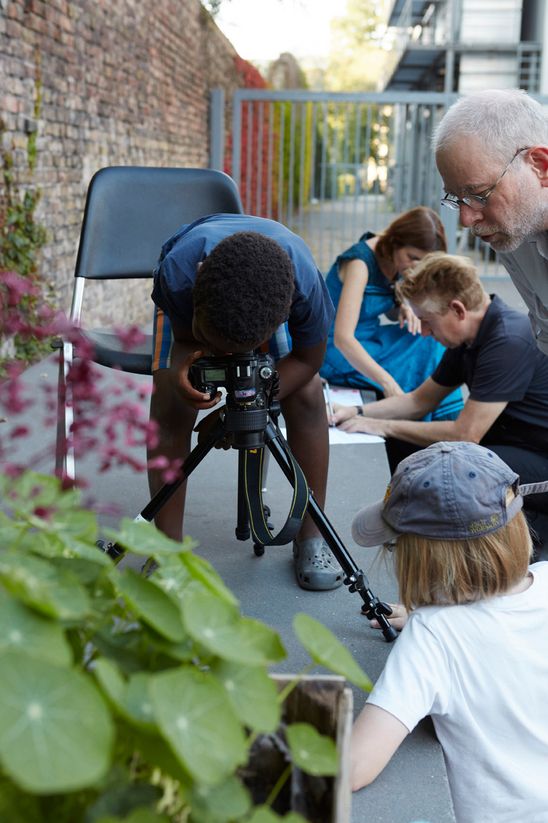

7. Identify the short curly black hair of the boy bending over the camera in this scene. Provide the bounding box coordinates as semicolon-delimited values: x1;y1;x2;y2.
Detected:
192;232;295;347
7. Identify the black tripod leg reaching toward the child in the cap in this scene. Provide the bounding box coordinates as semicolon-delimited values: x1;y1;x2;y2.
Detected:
265;422;397;642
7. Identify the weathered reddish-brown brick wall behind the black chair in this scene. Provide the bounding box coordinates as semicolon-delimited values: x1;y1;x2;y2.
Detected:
0;0;238;323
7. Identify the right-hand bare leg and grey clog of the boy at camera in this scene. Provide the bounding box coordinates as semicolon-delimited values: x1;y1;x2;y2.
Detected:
282;374;344;591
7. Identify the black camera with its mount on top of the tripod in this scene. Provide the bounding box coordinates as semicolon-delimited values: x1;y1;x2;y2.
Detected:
189;351;279;449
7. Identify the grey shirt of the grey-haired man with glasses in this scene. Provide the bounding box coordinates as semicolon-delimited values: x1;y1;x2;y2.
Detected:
499;232;548;354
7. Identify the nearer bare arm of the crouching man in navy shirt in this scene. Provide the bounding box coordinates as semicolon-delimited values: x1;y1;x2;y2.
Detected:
340;398;507;446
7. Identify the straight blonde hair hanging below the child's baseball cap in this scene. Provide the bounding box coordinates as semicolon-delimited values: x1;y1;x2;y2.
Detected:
394;511;533;611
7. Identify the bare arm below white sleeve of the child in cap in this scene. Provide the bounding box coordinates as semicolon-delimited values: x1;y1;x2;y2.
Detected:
350;703;409;792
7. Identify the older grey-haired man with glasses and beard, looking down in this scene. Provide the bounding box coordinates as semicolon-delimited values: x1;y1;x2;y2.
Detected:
434;89;548;354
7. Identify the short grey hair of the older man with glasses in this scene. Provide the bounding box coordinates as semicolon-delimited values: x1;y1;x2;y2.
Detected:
432;89;548;162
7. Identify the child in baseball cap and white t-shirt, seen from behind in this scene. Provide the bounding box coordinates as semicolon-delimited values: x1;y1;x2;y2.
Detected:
351;442;548;823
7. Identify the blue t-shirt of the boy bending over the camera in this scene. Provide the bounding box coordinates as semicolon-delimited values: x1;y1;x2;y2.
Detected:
152;214;335;348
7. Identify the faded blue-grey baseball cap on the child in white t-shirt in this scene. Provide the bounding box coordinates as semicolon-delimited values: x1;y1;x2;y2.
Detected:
352;442;548;546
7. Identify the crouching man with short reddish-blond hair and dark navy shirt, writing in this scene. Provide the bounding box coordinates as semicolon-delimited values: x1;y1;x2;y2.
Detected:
333;253;548;545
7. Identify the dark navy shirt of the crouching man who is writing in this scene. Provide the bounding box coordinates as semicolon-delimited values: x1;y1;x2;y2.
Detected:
432;295;548;428
